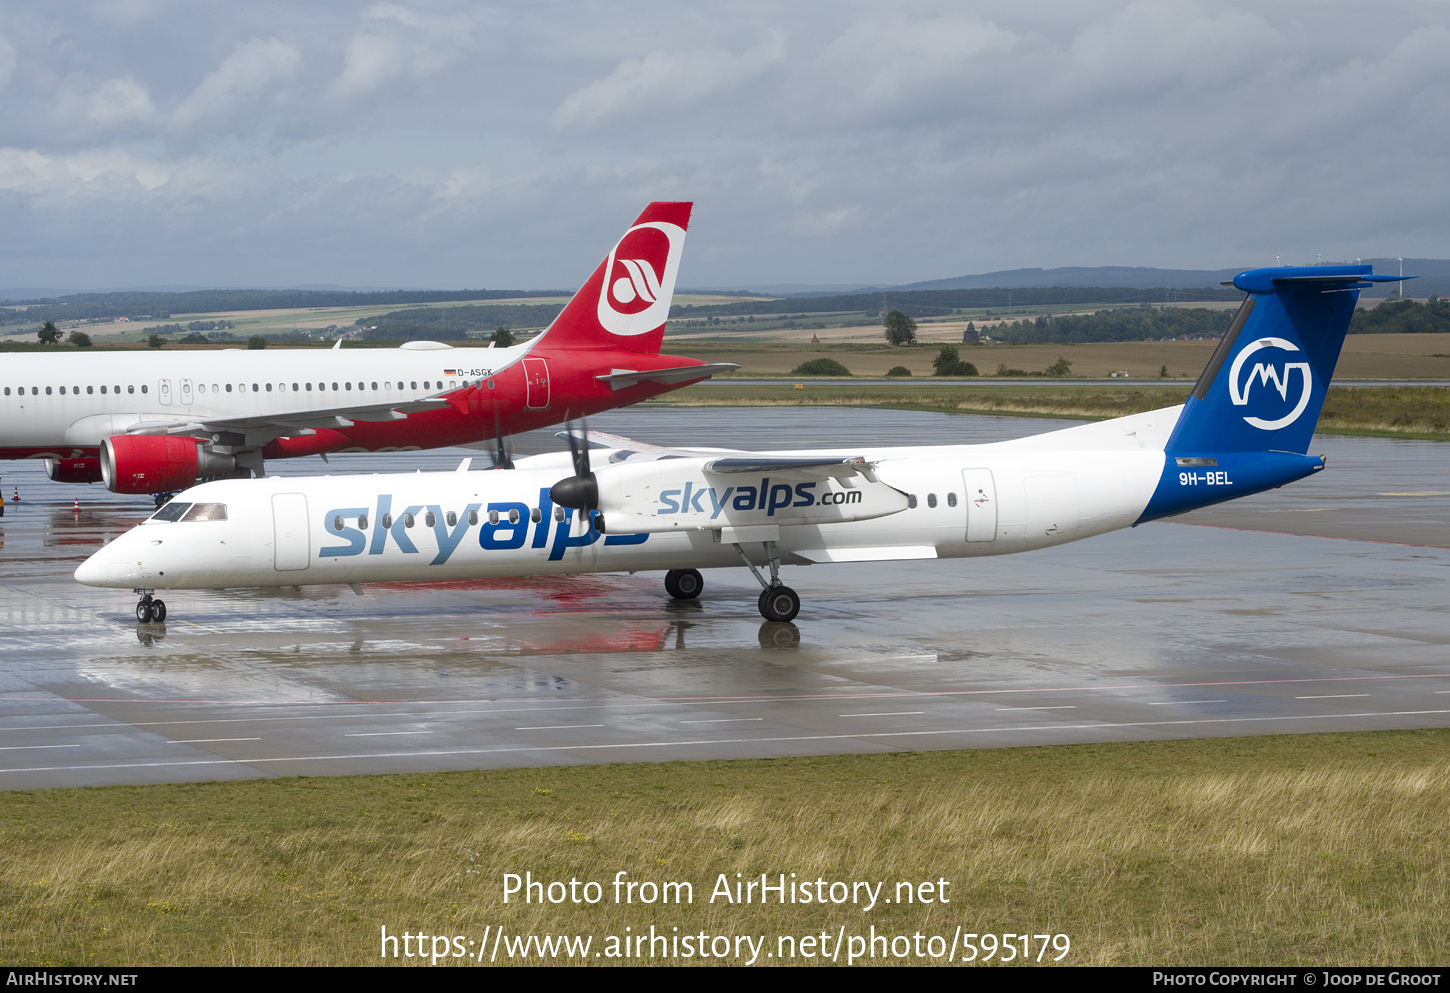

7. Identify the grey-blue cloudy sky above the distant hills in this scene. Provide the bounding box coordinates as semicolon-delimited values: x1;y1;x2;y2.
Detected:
0;0;1450;288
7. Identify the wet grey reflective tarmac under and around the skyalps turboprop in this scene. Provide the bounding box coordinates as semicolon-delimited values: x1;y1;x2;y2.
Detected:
0;409;1450;789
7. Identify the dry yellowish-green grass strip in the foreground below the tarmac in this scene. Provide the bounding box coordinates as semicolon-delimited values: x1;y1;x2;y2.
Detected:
0;731;1450;965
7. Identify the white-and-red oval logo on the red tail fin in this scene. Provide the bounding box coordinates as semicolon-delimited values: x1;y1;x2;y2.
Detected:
597;222;684;336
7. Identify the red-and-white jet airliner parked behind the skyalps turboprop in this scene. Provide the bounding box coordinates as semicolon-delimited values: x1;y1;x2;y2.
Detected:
0;203;735;493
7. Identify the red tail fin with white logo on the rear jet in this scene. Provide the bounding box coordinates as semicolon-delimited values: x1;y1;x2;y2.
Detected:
531;201;695;355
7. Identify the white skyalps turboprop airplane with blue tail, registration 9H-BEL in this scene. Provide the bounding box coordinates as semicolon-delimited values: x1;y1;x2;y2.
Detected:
75;265;1398;622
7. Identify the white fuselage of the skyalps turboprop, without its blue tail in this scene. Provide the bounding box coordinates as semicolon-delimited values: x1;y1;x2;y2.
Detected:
75;407;1179;589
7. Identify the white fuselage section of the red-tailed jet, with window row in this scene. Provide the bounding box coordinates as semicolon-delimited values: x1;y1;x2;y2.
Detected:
0;342;526;458
